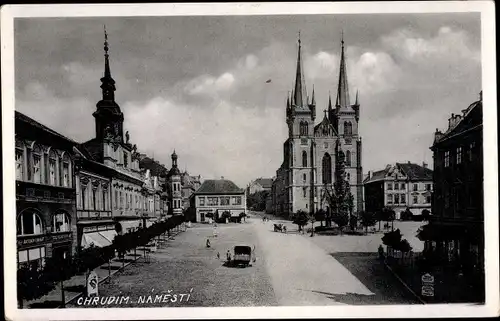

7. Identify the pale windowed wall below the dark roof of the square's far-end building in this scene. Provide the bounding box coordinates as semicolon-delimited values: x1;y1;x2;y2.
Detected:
194;193;246;222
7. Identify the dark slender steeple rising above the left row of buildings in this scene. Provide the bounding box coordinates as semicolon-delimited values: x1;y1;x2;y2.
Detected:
92;29;124;143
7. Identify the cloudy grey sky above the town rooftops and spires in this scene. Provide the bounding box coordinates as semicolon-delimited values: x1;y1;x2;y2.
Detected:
14;13;481;186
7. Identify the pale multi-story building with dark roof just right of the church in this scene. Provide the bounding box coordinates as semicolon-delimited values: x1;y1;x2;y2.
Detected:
364;162;432;219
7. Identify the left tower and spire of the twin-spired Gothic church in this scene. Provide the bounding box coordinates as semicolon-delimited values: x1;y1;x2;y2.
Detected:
284;34;316;213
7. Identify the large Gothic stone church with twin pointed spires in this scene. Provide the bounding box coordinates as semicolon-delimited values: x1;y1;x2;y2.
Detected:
272;39;363;217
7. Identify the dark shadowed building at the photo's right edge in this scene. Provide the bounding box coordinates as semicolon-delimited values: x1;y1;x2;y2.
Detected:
420;94;484;285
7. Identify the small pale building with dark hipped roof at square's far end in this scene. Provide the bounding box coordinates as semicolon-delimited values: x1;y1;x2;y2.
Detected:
193;178;246;222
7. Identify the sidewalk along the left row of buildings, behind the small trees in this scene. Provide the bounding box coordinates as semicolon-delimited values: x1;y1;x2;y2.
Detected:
23;230;182;309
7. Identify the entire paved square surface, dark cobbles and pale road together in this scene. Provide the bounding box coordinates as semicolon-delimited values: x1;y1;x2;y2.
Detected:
75;213;417;307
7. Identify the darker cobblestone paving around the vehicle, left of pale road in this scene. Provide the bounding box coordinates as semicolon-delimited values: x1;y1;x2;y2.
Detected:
71;223;277;307
